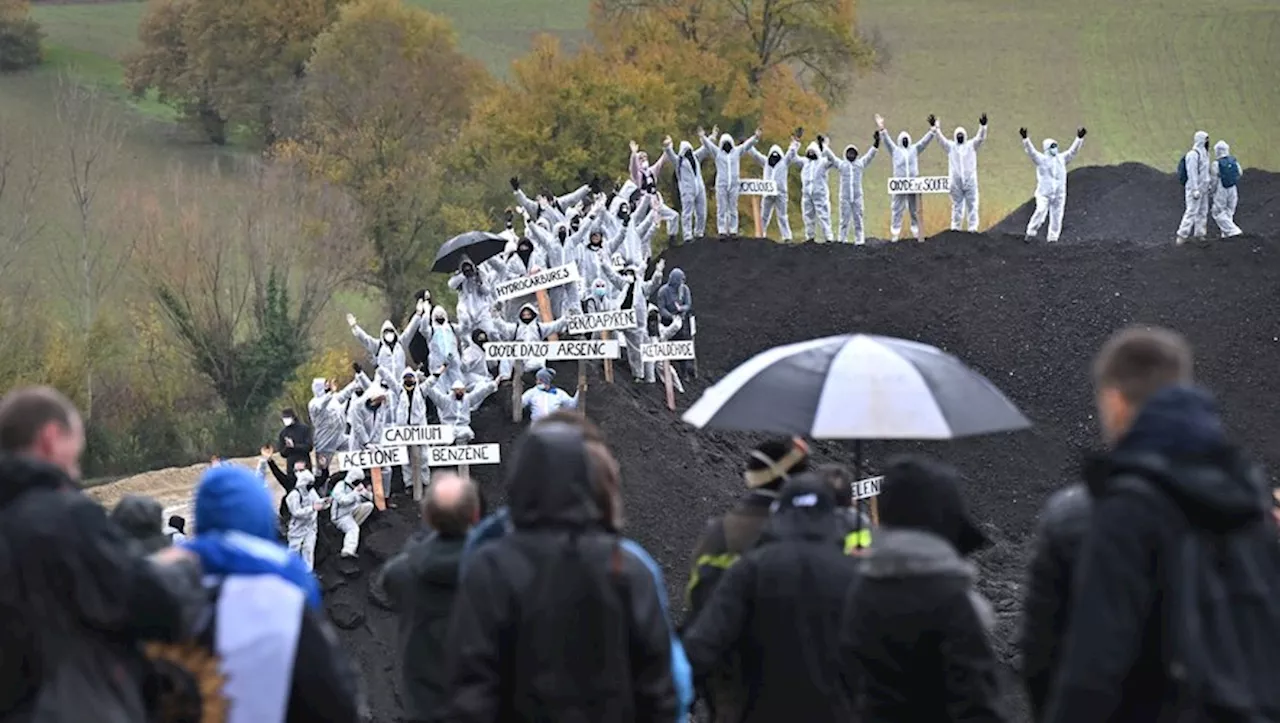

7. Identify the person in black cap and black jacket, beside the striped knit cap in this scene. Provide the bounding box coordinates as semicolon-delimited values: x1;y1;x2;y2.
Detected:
684;473;858;723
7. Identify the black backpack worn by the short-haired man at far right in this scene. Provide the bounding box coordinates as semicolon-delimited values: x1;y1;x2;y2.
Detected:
1116;475;1280;723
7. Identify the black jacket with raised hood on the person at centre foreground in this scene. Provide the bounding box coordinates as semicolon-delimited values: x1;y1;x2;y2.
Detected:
447;422;677;723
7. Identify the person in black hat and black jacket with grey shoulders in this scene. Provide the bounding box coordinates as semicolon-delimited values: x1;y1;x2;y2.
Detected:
844;457;1003;723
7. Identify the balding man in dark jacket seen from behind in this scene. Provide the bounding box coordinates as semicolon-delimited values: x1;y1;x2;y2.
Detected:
375;472;480;723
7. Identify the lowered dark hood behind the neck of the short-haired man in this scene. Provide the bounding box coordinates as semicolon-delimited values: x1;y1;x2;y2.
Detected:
1087;386;1271;531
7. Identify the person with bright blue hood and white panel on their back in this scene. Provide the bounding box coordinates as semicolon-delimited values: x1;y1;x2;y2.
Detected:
182;465;362;723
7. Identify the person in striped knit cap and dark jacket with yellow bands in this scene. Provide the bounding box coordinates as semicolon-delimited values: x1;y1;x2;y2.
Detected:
685;439;809;723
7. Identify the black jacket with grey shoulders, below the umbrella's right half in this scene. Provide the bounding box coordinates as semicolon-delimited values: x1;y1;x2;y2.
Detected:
842;527;1008;723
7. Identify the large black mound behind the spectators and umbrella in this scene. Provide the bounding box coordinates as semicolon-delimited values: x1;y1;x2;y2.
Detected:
319;220;1280;720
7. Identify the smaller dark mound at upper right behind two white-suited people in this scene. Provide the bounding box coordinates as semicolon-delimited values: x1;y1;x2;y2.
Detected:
991;157;1280;246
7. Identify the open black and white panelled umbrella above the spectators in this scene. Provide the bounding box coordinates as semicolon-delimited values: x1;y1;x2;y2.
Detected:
684;334;1030;440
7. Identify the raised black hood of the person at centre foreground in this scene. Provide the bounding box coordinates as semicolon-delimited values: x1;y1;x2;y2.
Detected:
507;422;604;530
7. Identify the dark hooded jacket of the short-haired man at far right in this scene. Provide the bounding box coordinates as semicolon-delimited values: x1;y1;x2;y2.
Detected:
1044;386;1280;723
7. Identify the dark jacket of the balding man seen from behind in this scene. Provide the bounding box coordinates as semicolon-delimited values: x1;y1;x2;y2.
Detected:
381;532;466;720
